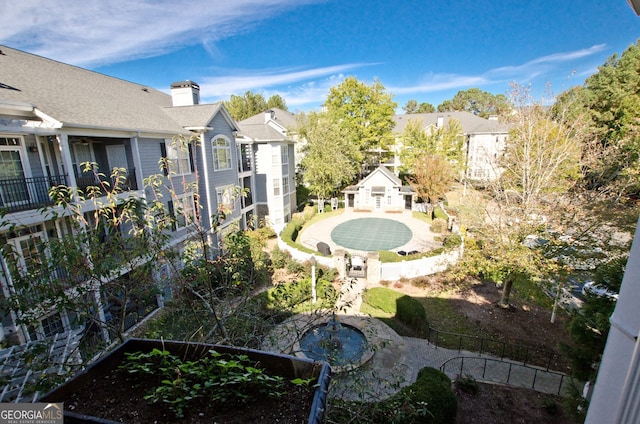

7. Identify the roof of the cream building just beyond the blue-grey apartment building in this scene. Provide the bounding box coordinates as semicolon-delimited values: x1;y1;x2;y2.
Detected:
238;108;297;141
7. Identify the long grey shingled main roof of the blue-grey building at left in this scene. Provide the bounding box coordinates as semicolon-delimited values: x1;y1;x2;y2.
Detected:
0;45;185;134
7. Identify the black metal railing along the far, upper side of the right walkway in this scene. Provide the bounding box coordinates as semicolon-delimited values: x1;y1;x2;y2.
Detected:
427;327;566;370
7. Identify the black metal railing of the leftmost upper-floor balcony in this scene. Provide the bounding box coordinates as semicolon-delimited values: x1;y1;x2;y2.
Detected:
0;175;67;212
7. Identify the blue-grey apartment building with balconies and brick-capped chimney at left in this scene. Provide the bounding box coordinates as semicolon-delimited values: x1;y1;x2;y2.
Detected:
0;46;255;344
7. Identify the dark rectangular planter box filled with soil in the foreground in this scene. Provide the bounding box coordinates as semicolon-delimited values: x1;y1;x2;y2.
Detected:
40;339;330;424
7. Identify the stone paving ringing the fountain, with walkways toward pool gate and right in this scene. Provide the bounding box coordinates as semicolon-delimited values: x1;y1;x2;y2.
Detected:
262;279;569;401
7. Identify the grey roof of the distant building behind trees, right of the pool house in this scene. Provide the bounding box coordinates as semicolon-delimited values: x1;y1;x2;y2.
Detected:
393;112;509;134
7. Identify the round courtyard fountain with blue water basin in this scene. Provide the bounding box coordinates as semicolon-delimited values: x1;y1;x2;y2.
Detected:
300;313;373;372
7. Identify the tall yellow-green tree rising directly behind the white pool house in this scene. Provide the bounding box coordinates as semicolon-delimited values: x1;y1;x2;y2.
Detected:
324;77;396;175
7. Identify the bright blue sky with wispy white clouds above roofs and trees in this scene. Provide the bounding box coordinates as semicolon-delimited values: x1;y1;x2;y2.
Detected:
0;0;640;111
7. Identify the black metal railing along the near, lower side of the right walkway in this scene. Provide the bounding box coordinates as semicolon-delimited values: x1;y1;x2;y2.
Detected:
440;356;571;395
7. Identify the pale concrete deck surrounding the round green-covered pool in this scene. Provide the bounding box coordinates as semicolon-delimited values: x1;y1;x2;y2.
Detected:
298;209;440;253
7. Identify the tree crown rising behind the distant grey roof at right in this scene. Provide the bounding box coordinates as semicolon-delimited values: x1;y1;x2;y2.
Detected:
438;88;510;118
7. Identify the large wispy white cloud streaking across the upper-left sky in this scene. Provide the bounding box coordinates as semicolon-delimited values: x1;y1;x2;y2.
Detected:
0;0;323;66
